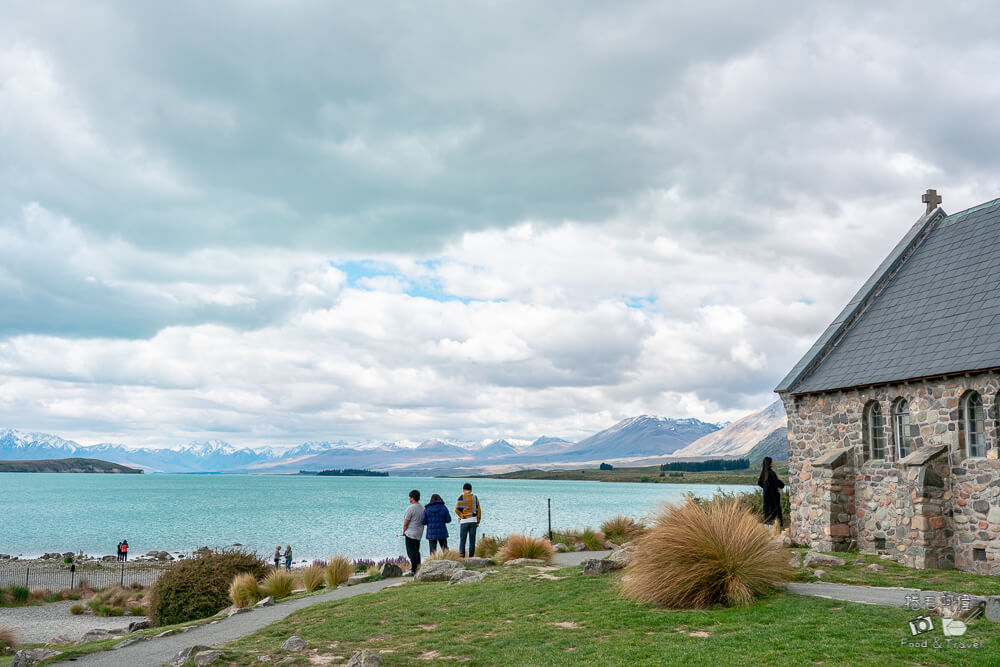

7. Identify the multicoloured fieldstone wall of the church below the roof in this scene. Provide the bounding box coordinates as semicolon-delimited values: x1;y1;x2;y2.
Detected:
782;372;1000;574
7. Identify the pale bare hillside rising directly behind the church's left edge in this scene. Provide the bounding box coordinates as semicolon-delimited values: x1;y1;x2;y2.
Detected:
673;401;788;463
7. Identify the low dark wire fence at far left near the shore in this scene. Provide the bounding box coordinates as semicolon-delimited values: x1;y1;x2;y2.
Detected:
0;562;169;591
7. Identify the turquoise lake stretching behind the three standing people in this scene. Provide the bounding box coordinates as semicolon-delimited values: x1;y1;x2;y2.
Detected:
0;473;755;561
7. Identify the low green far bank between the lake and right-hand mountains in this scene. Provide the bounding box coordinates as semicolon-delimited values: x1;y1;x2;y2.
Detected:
481;461;788;485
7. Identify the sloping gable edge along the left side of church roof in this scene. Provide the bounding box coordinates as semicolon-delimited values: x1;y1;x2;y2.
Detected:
774;208;949;393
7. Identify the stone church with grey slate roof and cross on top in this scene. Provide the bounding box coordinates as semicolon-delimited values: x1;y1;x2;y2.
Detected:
775;190;1000;575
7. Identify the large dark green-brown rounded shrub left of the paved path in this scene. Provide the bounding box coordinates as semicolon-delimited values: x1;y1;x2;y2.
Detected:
148;549;269;625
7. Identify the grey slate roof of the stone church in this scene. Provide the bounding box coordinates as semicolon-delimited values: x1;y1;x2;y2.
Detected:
775;199;1000;394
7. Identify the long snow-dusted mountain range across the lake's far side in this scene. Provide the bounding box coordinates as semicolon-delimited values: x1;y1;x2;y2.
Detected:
0;402;788;475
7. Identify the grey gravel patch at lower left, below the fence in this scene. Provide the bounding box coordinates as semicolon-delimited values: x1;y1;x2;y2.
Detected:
0;600;144;644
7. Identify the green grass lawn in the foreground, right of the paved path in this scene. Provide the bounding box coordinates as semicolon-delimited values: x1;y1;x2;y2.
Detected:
221;567;1000;666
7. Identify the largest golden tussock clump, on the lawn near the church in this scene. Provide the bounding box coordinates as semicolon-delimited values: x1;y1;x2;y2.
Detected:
622;499;791;609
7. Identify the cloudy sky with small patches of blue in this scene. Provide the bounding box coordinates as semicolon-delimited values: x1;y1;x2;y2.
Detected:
0;0;1000;446
